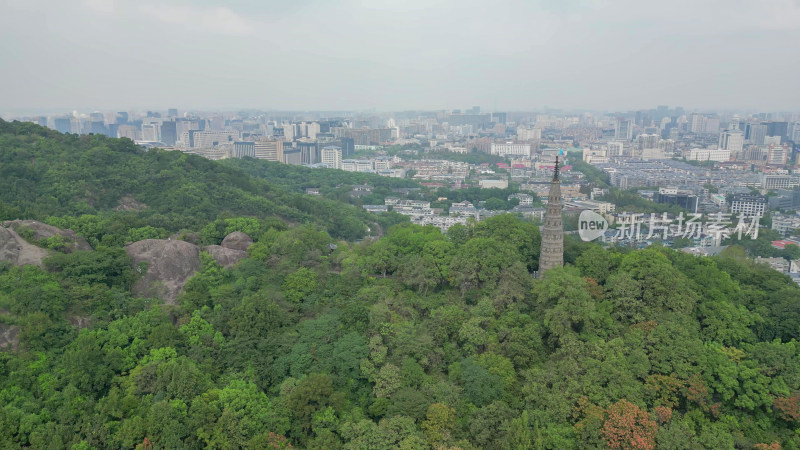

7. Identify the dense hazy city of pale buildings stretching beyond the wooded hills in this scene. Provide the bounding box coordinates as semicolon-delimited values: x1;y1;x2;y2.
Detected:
10;106;800;282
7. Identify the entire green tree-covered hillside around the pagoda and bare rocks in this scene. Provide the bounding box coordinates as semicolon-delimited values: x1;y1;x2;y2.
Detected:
0;123;800;450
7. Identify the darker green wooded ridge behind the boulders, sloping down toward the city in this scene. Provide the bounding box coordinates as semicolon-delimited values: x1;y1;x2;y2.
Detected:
0;119;390;239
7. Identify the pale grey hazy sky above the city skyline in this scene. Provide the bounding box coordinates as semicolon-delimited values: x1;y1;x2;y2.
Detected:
0;0;800;112
